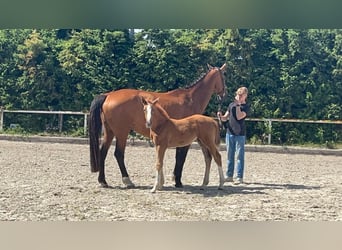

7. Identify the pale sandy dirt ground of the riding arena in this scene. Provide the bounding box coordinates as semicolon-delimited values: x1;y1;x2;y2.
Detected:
0;140;342;221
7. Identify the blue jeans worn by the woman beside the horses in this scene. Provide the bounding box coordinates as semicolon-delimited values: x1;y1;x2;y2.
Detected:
226;133;246;178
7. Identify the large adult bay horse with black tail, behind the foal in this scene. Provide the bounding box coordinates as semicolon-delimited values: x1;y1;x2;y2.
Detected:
89;64;226;187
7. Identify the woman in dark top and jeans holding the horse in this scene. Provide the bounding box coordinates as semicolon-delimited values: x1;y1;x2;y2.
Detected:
217;87;250;184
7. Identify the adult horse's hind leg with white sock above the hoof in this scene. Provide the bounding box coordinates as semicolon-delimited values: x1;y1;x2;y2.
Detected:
114;131;134;188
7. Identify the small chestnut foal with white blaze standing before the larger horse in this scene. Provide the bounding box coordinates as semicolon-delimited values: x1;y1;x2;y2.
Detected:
141;97;224;193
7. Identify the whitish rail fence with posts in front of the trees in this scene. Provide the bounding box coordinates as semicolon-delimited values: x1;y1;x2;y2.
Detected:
0;107;342;144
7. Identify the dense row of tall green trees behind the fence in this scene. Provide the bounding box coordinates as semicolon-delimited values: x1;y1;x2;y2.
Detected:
0;29;342;142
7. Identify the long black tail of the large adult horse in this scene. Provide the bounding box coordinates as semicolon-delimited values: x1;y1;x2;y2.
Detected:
88;95;107;172
